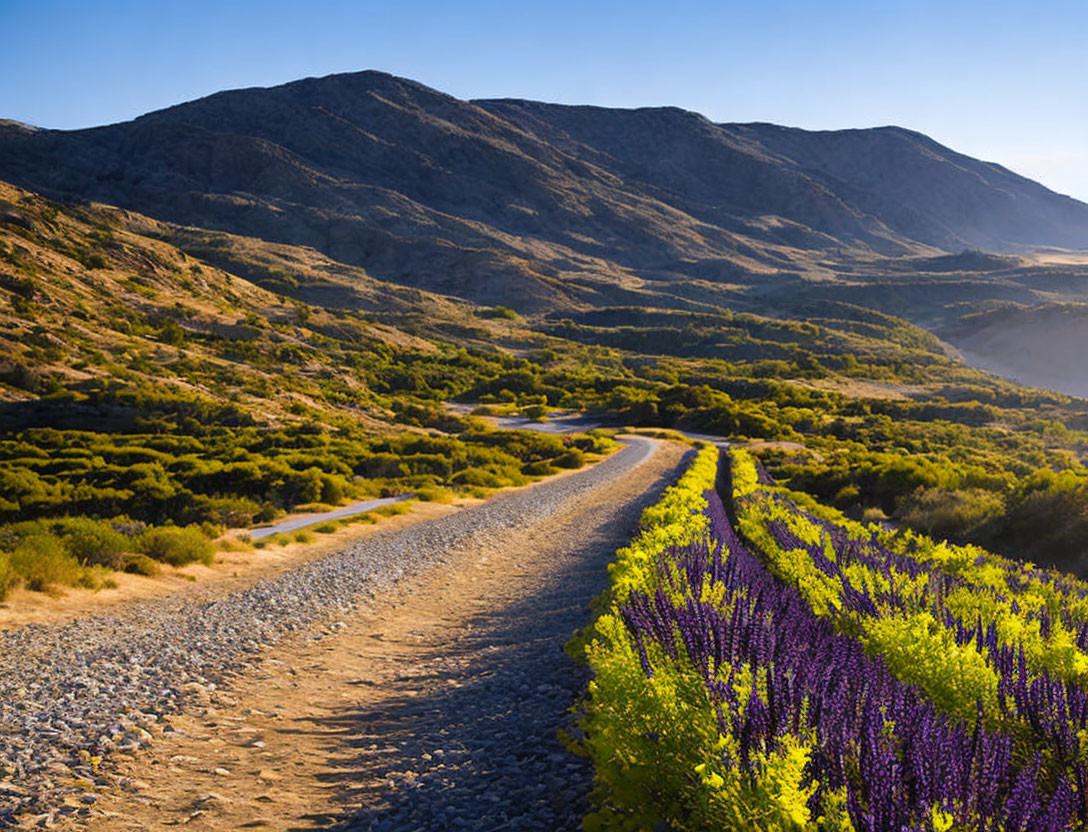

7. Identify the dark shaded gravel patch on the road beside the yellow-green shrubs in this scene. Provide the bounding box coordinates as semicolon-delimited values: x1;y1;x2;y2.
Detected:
333;617;603;832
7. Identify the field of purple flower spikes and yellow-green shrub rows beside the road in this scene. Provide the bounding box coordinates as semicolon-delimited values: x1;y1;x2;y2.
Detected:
573;447;1088;832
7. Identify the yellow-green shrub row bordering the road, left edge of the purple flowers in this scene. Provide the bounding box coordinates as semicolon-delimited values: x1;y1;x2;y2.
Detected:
568;446;720;830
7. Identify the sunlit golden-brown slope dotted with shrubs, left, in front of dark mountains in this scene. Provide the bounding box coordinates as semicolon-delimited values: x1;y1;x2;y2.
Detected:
0;182;539;432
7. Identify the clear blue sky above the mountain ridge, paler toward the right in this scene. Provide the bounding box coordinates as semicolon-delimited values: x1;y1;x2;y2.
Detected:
6;0;1088;200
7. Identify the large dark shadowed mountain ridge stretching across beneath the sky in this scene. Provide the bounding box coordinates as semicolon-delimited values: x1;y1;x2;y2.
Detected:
0;72;1088;311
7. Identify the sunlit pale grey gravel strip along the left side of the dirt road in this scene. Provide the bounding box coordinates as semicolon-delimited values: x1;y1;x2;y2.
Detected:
0;439;654;829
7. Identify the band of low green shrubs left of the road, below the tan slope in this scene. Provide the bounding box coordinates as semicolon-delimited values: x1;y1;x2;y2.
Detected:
0;426;615;600
